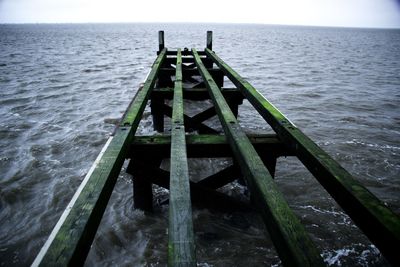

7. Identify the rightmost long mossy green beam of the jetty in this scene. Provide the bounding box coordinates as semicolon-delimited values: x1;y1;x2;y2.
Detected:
206;49;400;265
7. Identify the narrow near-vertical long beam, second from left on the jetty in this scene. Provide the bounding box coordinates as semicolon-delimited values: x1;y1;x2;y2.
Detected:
168;50;197;266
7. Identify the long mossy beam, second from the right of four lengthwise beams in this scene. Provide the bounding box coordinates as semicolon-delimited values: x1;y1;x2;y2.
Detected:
192;49;324;266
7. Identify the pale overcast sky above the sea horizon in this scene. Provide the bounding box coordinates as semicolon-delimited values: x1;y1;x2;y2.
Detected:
0;0;400;28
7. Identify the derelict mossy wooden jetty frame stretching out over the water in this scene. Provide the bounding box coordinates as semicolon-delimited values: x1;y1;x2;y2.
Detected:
32;31;400;266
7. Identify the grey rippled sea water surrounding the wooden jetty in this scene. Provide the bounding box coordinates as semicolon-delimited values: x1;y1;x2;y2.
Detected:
0;24;400;266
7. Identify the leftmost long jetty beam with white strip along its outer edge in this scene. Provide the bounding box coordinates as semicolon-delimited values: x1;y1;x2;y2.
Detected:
32;49;166;266
